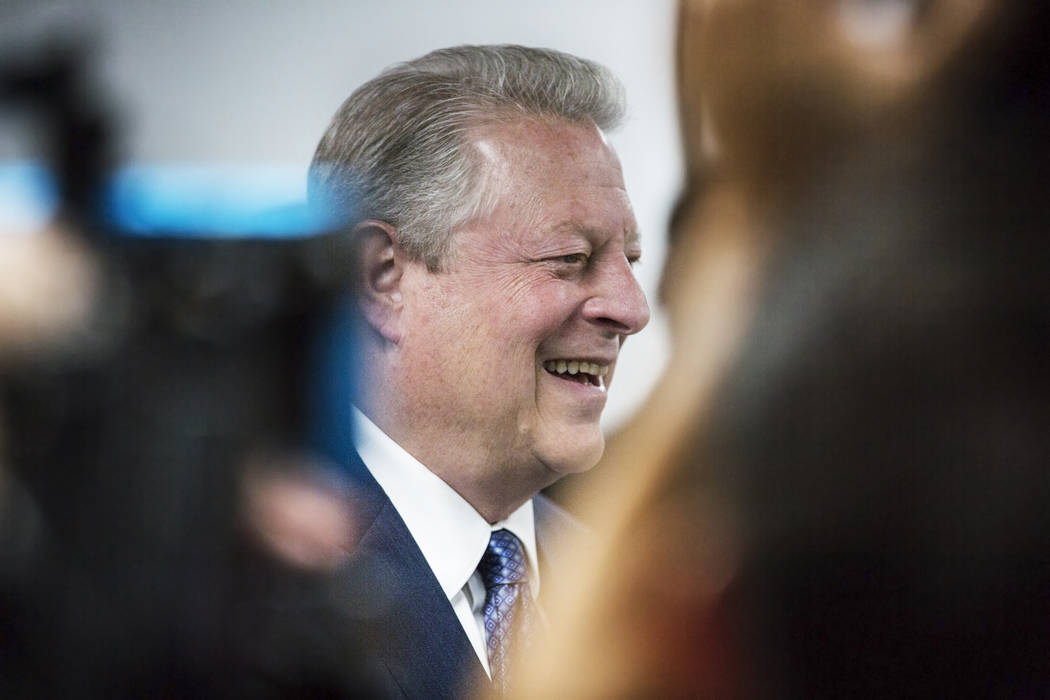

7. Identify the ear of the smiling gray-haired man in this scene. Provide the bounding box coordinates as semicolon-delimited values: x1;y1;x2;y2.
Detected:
354;219;405;344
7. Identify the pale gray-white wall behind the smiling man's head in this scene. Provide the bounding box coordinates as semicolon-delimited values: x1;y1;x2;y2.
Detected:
0;0;681;428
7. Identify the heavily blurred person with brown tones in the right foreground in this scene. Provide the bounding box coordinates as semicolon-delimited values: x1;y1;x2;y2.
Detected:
519;0;1050;698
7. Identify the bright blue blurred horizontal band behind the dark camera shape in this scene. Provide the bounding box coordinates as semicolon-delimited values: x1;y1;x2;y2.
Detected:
0;162;339;238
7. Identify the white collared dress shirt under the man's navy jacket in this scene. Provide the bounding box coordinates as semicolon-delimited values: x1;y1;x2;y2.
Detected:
354;407;540;675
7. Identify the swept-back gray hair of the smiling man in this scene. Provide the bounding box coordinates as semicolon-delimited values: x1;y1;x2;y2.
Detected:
310;45;625;271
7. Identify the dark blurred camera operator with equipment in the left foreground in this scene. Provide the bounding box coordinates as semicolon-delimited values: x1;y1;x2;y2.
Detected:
0;41;372;698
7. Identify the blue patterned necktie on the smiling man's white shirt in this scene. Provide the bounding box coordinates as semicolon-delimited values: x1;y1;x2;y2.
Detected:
478;530;532;693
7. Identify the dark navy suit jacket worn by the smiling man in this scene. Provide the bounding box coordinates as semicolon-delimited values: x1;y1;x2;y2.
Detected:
340;453;584;700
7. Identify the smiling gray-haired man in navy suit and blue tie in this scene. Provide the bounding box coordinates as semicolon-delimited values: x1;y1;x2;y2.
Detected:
311;46;649;698
